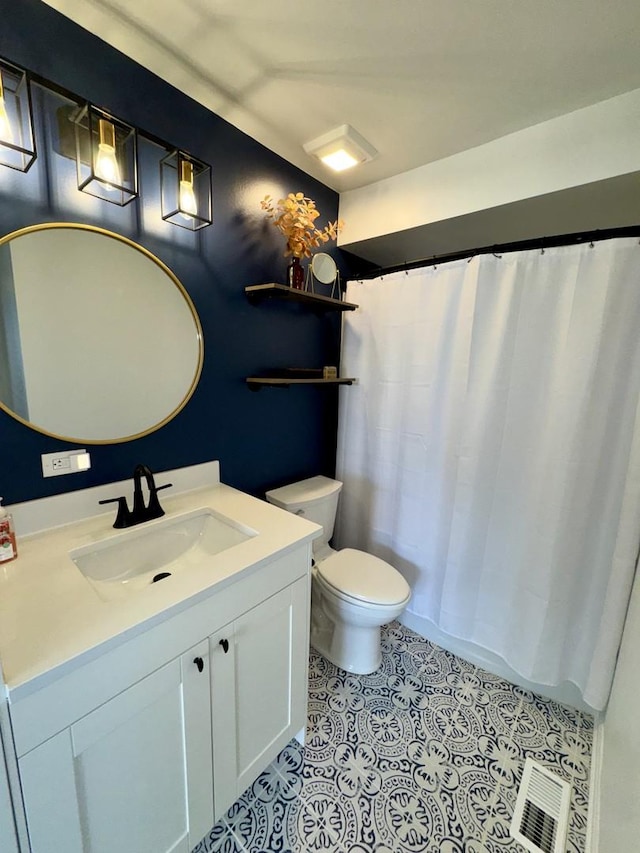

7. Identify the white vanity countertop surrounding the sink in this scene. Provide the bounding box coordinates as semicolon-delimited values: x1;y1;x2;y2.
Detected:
0;483;320;697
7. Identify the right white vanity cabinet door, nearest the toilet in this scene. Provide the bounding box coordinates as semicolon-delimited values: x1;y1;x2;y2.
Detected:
211;578;309;819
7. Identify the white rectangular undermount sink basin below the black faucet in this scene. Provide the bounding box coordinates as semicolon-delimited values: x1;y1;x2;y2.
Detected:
69;509;257;600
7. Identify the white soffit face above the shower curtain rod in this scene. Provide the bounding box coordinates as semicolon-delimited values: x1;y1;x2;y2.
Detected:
339;89;640;257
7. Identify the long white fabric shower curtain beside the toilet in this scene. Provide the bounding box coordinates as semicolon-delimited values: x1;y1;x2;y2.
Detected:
337;239;640;708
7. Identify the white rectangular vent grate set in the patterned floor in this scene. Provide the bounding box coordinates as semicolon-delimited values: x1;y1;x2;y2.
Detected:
510;758;571;853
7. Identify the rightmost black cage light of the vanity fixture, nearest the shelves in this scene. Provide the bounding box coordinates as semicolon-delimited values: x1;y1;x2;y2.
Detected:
160;150;213;231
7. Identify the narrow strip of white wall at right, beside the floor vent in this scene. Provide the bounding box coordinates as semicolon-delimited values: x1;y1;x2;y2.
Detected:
596;564;640;853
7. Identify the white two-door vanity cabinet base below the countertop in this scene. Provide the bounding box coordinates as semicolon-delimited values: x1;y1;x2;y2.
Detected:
12;544;310;853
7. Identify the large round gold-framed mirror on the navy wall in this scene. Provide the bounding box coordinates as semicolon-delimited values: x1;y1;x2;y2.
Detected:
0;223;203;444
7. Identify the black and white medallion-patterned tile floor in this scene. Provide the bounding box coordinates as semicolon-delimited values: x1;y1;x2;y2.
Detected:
193;622;593;853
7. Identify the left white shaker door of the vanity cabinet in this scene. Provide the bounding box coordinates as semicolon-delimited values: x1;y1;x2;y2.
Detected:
20;642;213;853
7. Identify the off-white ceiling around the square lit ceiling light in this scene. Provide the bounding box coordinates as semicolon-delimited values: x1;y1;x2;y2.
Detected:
41;0;640;191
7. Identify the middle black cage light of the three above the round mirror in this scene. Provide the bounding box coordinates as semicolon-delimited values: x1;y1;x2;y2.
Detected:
75;104;138;207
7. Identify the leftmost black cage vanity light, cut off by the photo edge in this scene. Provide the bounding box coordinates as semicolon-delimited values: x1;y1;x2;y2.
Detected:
0;61;36;172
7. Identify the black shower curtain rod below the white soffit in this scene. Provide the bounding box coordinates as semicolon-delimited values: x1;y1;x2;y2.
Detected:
352;225;640;281
